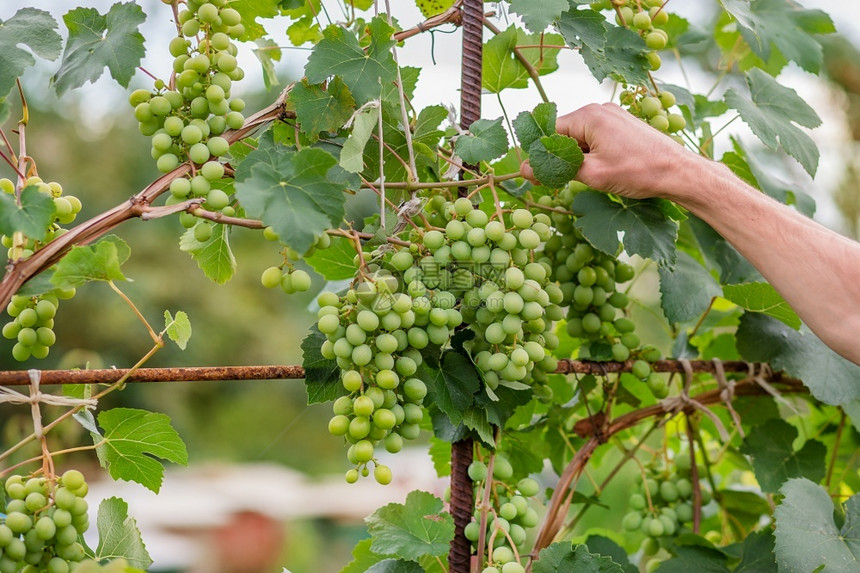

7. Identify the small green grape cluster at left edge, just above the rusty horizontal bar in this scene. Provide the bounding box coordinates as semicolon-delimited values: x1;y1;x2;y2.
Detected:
3;288;75;362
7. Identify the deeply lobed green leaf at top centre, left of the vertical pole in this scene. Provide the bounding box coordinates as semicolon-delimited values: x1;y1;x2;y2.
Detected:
305;16;397;104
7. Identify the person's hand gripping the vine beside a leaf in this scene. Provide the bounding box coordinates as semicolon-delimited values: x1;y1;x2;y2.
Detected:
522;103;704;199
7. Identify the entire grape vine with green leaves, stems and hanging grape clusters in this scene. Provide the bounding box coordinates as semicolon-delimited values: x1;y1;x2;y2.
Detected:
0;0;860;573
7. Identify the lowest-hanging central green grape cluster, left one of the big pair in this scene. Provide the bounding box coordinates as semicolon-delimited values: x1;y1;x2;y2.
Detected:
317;269;462;485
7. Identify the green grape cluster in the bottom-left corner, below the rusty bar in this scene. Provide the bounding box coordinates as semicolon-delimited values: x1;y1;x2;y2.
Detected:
0;470;89;573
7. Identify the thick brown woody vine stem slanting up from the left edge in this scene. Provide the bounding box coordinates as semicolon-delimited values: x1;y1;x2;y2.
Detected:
0;87;295;306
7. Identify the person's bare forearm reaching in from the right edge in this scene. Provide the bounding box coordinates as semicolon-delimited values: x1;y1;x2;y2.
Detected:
667;158;860;363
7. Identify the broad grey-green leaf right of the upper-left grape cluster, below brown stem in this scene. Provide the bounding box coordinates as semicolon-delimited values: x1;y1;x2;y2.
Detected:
236;147;346;253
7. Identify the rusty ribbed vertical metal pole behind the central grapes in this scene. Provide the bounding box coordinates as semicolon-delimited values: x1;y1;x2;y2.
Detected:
448;0;484;573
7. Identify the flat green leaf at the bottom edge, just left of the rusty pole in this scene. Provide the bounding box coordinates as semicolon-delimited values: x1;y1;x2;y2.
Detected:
365;491;454;560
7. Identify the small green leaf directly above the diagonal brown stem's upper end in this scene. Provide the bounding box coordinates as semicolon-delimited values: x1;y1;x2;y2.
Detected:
289;77;355;140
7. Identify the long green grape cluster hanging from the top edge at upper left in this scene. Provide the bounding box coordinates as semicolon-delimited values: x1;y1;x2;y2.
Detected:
129;0;245;226
